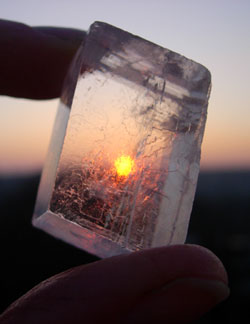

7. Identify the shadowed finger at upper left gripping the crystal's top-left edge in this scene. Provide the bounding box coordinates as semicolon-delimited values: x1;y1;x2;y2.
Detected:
0;20;86;99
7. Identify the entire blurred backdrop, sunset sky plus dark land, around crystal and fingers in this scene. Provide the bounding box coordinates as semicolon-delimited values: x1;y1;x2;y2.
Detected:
0;0;250;323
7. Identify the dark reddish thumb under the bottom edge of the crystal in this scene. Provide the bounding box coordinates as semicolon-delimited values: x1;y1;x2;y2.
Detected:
0;245;229;324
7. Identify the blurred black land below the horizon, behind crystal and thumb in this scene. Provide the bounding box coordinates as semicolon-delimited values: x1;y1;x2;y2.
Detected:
0;171;250;324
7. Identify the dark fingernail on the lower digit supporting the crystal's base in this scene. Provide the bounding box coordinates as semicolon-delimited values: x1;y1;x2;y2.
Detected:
122;278;229;324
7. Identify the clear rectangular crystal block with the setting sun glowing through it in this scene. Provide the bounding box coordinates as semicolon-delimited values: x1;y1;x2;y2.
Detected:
33;22;211;257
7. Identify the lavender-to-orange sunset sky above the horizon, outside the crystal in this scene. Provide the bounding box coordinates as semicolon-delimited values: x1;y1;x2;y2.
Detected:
0;0;250;175
